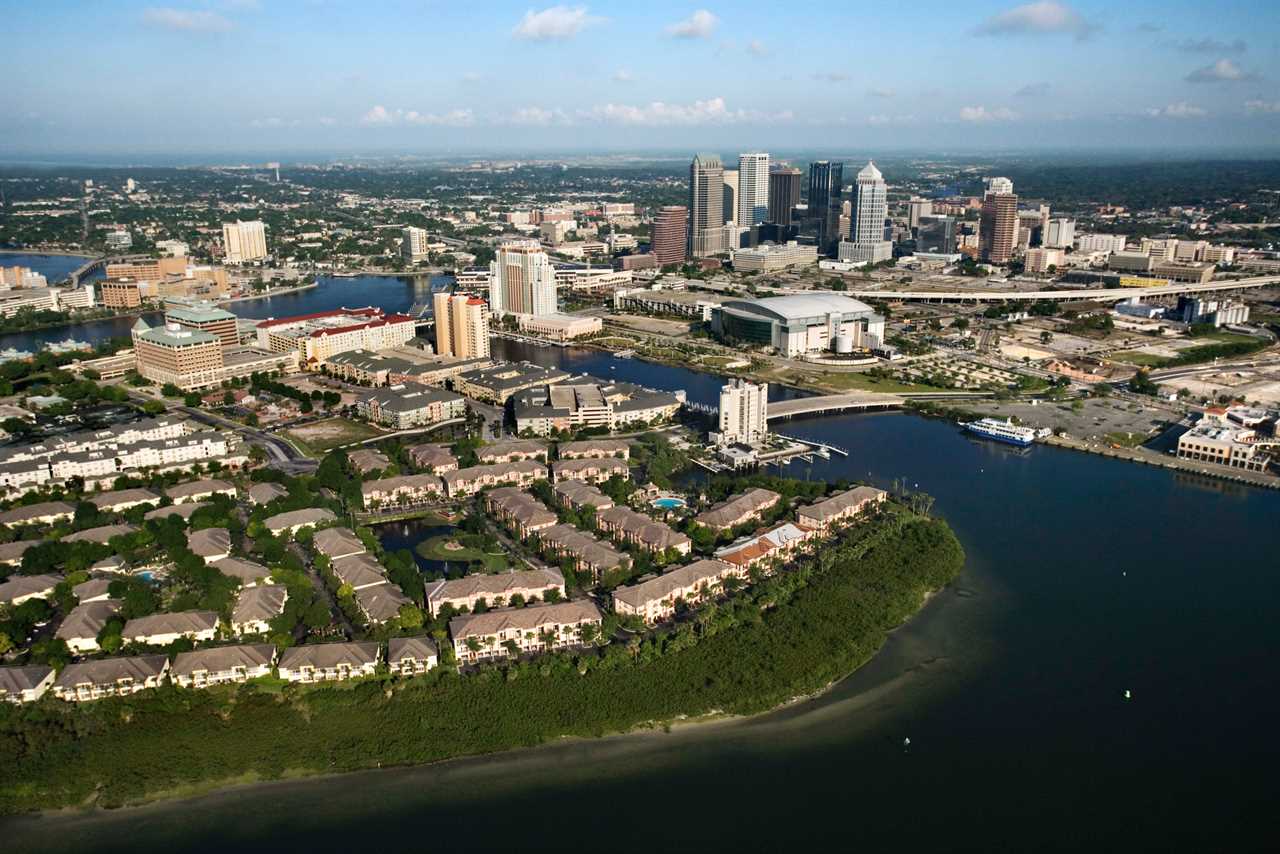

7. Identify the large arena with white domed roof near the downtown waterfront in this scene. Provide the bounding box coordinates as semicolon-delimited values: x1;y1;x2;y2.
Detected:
712;293;884;356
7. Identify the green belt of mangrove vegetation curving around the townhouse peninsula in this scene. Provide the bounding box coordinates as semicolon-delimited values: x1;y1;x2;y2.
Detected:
0;504;964;813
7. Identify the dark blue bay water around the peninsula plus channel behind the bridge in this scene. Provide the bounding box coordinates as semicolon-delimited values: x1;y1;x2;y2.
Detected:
5;325;1280;851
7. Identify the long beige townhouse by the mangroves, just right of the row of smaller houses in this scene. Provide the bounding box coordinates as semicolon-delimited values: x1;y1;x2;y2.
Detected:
449;599;603;663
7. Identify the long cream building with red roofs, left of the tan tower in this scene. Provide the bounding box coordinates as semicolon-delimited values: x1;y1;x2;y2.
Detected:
249;306;417;366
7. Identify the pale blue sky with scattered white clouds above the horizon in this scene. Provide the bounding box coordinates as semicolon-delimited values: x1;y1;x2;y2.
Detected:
0;0;1280;161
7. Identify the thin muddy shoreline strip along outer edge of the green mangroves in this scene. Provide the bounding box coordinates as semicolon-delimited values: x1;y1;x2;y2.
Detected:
15;576;960;827
